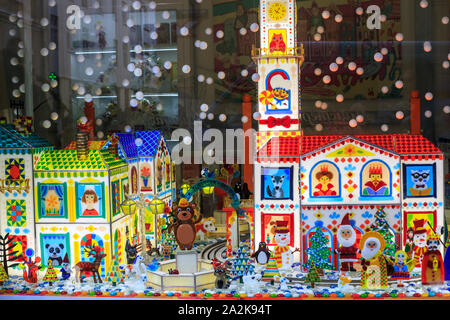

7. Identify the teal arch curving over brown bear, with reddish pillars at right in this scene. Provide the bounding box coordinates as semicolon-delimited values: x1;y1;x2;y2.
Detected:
184;178;254;255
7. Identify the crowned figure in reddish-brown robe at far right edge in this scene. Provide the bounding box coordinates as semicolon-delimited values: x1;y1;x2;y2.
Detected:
422;234;445;285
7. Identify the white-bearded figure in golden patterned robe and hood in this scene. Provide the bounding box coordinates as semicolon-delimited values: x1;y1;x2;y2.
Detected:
354;231;389;290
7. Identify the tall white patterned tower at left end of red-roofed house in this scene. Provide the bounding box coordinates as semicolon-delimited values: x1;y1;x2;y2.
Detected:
252;0;304;269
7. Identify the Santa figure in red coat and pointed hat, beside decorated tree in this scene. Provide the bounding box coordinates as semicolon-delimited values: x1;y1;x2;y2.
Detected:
335;213;358;271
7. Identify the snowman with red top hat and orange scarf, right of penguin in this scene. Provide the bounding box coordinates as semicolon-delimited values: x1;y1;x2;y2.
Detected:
273;221;294;271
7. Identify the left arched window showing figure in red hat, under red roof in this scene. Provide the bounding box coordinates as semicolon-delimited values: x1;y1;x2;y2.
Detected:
309;161;342;201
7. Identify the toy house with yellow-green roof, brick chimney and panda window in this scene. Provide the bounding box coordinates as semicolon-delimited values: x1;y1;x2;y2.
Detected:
34;133;130;276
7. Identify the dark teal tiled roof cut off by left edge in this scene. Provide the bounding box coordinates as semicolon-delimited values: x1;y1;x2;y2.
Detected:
0;124;52;149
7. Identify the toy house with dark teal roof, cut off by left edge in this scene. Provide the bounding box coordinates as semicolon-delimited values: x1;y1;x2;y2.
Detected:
0;123;53;272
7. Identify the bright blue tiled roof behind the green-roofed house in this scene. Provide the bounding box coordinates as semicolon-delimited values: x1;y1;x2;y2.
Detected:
103;130;164;159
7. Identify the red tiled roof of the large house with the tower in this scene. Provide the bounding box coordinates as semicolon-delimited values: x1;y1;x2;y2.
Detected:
257;133;442;161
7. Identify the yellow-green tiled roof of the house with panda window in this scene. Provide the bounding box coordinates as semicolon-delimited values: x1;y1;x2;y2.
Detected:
35;150;126;171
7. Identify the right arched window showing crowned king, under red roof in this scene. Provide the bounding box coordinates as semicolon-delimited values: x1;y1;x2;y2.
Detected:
359;160;393;201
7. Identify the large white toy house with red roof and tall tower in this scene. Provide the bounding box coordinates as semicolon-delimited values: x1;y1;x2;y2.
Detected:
253;0;444;266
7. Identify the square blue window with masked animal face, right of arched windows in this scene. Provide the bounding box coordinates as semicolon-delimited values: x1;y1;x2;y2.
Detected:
403;163;436;198
